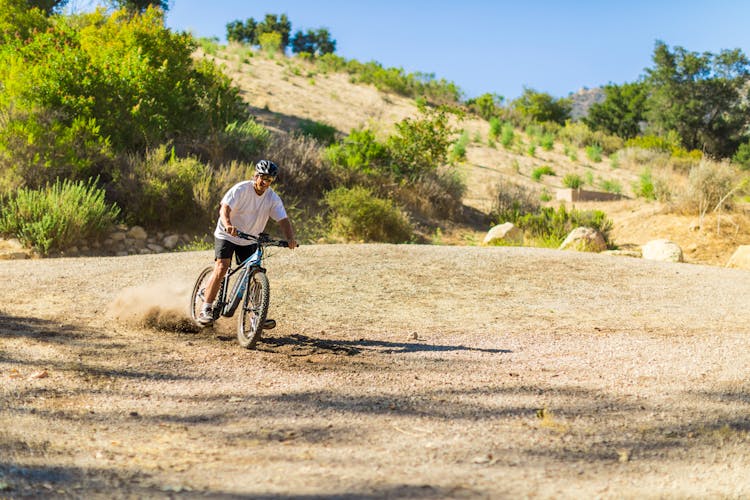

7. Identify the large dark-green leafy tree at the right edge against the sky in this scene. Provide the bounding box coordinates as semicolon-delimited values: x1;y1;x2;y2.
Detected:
647;41;750;157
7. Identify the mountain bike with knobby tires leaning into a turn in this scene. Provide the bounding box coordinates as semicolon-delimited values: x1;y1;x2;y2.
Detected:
190;231;289;349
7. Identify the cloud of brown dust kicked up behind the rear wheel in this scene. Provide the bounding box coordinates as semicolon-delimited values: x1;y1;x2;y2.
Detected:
108;282;199;332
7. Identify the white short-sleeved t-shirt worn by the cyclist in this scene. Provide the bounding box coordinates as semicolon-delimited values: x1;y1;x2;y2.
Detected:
214;181;287;246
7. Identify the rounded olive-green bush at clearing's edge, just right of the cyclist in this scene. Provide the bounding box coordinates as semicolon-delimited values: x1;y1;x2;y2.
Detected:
325;186;412;243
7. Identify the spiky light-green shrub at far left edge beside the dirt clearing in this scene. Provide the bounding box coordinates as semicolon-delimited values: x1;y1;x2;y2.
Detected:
0;179;120;255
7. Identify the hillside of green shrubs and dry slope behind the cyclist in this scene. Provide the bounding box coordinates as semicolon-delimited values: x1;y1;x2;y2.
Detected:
0;0;750;263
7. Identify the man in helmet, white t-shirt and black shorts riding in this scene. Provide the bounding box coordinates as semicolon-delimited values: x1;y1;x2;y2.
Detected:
198;160;297;326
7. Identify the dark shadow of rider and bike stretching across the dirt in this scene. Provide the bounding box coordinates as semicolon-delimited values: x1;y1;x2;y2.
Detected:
257;333;512;356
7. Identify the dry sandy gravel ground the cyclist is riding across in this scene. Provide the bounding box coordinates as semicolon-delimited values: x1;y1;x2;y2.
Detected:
0;245;750;498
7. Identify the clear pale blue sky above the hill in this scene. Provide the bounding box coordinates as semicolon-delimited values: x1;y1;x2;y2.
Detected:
114;0;750;99
